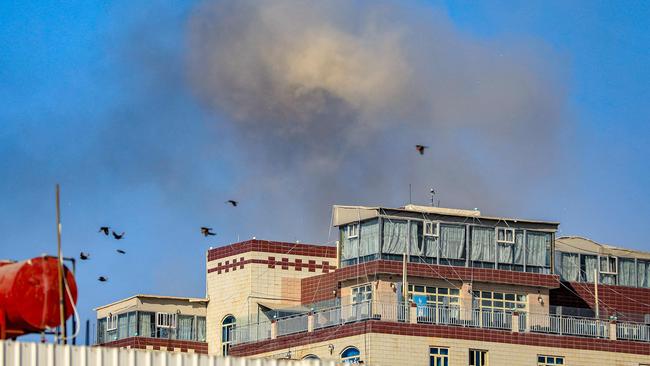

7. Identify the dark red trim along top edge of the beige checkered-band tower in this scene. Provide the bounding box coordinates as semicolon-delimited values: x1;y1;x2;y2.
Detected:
207;239;336;262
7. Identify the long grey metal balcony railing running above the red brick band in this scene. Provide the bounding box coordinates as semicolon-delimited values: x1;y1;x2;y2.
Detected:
228;301;650;344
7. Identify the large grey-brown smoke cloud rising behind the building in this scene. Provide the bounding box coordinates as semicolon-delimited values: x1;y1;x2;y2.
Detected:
188;1;568;237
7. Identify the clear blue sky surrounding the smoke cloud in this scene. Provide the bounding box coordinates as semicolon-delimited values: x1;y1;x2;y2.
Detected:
0;0;650;344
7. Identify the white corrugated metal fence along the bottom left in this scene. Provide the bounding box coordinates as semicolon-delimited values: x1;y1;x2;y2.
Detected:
0;341;336;366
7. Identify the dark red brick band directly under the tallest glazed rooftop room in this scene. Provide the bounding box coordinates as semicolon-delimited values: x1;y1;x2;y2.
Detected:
301;260;560;304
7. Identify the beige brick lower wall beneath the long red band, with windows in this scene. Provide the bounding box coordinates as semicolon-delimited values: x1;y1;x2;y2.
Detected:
246;333;650;366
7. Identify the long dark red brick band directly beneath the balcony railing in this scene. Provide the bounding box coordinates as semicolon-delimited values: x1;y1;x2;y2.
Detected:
230;320;650;356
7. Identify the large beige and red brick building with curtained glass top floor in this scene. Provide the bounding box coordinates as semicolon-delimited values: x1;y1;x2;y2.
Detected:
92;205;650;366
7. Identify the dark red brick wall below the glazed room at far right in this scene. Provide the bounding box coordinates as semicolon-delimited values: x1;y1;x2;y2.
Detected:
550;282;650;322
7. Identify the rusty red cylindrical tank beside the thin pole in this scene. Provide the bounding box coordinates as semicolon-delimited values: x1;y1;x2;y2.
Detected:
0;256;77;339
